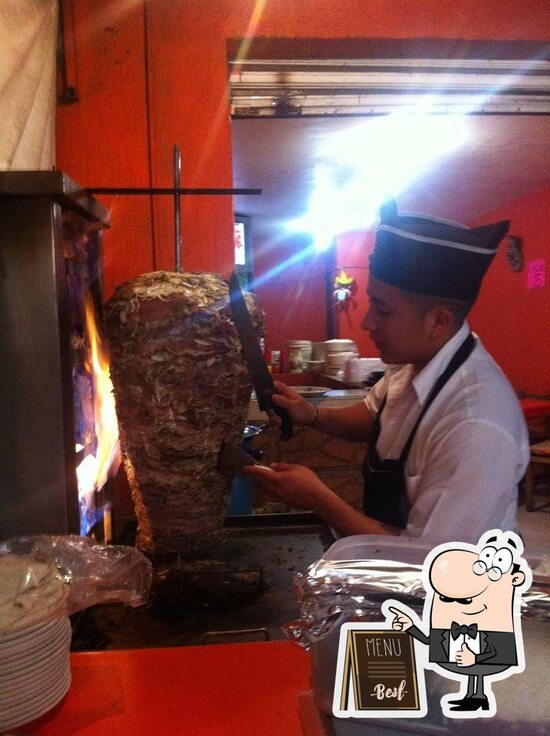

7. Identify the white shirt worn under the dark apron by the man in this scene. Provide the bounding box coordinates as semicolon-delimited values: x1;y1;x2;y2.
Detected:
365;323;530;543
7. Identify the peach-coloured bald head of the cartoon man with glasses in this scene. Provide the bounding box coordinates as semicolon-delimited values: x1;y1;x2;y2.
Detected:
430;548;525;632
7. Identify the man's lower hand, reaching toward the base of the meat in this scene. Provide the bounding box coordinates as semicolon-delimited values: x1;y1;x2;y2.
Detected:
244;463;333;511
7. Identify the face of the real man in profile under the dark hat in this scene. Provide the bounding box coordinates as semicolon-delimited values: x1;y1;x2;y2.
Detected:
361;276;431;364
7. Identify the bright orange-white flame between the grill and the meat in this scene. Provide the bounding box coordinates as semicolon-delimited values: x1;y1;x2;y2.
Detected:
76;295;120;506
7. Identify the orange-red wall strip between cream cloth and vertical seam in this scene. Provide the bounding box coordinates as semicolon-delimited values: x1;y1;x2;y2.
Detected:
56;2;154;296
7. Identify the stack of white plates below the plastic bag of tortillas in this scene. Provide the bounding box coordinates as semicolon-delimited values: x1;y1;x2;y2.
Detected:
0;618;71;732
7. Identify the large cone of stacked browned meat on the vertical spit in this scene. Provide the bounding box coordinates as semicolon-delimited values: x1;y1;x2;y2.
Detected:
105;271;263;559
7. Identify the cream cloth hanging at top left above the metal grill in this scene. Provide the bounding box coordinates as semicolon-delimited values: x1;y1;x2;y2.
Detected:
0;0;58;171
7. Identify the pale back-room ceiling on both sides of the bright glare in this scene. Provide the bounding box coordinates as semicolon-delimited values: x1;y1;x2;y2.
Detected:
232;115;550;233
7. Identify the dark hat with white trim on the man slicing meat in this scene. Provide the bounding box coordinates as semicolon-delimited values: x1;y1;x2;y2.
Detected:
370;201;510;302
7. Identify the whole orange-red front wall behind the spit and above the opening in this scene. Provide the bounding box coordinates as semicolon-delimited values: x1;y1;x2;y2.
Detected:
57;0;550;301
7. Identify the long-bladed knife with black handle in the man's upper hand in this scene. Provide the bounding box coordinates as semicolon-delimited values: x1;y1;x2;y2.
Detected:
229;271;292;440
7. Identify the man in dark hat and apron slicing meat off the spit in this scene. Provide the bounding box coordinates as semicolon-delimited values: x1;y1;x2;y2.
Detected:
247;204;529;541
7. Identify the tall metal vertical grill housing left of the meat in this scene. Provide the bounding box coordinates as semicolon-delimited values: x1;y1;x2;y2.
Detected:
0;171;113;538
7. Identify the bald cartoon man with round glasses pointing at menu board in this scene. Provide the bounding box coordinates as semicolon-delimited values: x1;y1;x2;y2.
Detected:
383;530;532;718
